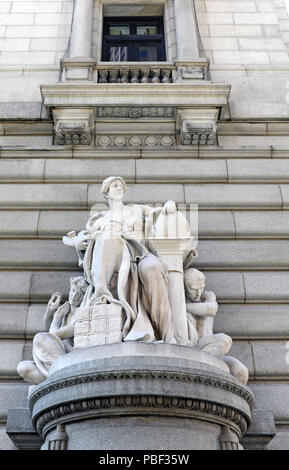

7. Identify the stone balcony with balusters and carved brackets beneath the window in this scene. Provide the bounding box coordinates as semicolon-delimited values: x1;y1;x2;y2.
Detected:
41;58;231;147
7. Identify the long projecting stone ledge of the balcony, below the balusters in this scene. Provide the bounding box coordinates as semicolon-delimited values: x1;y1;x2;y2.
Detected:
41;82;231;108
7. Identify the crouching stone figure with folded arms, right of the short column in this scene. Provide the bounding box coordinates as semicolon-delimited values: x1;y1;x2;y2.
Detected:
184;268;249;384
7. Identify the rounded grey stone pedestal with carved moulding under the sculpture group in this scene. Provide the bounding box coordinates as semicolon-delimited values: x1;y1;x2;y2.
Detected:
29;343;253;450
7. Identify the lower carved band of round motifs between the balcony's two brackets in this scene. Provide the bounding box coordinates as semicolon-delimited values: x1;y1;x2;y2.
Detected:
95;134;176;147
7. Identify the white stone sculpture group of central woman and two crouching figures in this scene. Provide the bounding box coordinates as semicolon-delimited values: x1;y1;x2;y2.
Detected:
18;176;248;384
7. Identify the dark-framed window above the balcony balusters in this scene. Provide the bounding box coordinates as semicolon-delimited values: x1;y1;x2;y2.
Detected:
102;17;166;62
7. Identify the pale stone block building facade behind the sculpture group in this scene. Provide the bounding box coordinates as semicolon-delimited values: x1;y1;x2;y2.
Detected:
0;0;289;449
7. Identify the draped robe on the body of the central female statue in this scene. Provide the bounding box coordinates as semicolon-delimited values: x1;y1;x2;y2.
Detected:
78;205;174;343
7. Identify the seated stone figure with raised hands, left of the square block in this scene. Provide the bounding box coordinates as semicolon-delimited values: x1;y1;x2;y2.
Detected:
17;277;87;385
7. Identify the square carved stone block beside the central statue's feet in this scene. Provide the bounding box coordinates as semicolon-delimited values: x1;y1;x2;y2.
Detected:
74;304;124;349
